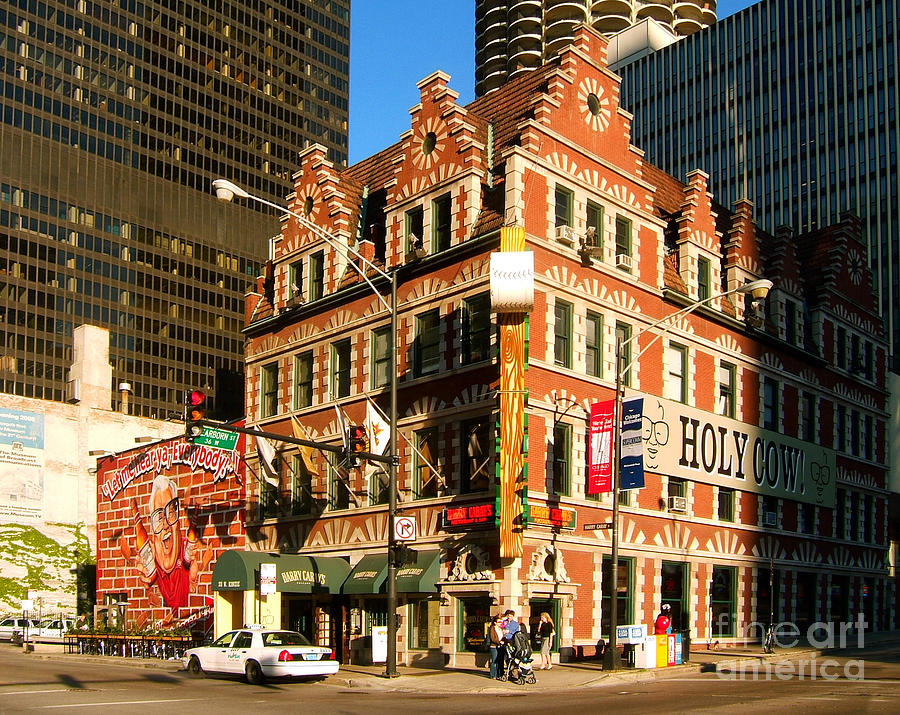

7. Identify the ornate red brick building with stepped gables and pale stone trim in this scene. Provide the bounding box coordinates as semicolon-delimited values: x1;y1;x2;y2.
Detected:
223;27;893;666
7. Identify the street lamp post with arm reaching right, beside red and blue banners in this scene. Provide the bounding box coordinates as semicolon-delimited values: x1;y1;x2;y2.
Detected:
603;278;772;670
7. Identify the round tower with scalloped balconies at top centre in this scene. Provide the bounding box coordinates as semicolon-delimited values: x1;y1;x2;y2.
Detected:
475;0;716;97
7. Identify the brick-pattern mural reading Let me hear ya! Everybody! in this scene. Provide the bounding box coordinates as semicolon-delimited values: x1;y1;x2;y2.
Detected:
97;436;245;629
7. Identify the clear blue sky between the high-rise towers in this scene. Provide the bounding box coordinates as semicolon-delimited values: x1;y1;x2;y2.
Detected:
350;0;755;164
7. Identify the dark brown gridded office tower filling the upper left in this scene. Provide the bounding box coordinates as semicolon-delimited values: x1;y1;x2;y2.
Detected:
0;0;350;417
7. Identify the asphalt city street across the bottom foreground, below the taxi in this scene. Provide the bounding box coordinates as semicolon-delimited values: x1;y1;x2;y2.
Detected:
0;644;900;715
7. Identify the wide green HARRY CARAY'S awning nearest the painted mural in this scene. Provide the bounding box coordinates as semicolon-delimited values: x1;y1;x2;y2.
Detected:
212;551;350;593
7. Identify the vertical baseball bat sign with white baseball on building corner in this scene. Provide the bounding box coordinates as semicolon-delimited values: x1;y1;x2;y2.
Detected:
491;226;534;558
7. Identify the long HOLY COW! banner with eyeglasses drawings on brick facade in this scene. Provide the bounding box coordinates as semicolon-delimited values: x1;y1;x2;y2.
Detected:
643;396;835;508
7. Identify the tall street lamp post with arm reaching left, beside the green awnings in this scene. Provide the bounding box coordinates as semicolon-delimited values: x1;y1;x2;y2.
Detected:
213;179;399;678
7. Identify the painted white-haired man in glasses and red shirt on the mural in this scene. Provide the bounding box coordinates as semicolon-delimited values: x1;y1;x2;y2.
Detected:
131;474;212;617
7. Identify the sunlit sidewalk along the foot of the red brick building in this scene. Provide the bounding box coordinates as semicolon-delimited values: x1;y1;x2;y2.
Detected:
10;634;832;694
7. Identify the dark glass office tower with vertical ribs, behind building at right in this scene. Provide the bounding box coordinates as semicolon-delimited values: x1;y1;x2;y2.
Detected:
614;0;900;371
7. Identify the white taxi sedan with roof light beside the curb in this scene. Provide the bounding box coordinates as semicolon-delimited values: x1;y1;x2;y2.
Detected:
182;627;339;683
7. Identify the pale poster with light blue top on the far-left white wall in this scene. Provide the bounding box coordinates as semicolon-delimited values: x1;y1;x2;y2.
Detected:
0;408;44;521
